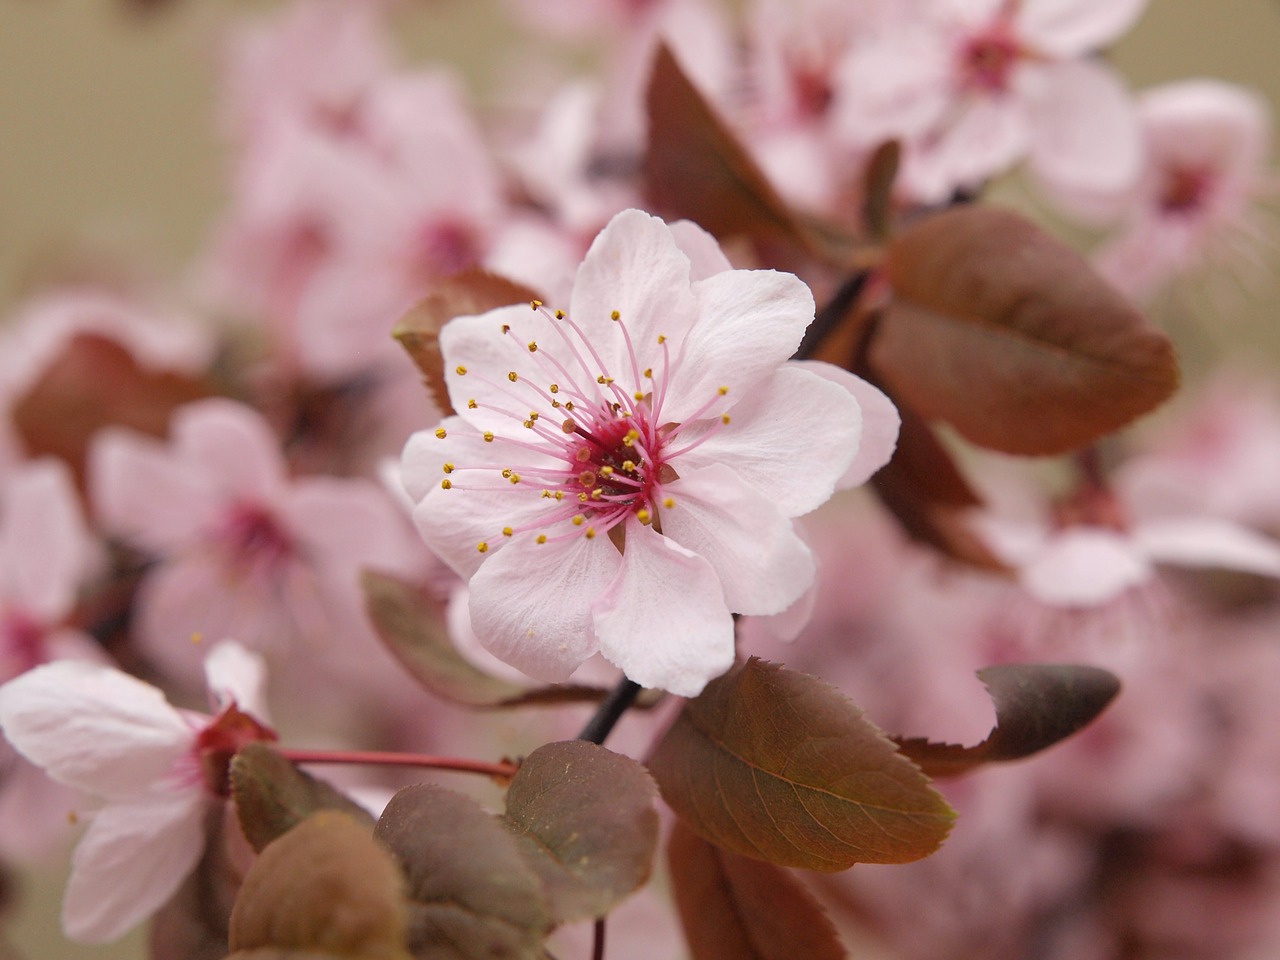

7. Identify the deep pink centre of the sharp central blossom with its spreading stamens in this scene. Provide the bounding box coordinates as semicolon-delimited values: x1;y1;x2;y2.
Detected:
436;302;728;553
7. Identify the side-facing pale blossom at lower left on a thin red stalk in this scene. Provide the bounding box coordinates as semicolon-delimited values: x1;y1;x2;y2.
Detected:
0;641;275;942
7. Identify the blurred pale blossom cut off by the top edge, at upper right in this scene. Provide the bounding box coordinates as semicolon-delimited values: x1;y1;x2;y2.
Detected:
833;0;1146;202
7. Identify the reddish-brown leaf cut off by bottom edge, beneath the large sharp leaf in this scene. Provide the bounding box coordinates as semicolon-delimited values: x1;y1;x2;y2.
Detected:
667;820;847;960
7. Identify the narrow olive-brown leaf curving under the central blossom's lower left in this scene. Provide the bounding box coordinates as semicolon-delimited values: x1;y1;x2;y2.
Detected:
360;570;608;707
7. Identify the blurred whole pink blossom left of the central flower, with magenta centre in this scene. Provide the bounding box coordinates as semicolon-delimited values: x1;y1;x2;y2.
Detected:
90;399;415;676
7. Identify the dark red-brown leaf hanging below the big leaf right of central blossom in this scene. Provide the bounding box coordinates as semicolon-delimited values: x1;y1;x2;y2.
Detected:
872;403;1006;571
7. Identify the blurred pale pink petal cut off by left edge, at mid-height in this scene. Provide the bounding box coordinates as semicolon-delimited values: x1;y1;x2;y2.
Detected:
0;458;95;623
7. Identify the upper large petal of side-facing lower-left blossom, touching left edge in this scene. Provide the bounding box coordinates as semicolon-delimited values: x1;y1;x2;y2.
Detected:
0;660;195;799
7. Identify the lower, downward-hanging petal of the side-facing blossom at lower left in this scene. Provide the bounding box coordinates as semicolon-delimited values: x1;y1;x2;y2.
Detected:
63;787;207;943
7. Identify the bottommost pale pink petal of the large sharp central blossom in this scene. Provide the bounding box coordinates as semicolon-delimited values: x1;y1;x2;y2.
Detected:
594;520;733;696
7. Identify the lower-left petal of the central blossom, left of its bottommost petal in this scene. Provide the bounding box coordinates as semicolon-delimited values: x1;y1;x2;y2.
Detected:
470;524;622;682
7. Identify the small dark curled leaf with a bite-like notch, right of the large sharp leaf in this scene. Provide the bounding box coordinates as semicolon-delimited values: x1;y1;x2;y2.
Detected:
897;663;1120;777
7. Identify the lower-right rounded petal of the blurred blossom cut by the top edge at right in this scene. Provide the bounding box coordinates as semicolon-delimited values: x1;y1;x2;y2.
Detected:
1028;61;1142;195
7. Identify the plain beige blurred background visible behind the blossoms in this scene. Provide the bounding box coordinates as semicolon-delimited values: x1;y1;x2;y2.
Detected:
0;0;1280;960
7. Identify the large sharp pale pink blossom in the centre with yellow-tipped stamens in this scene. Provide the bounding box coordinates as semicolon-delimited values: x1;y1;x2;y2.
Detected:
404;210;896;695
